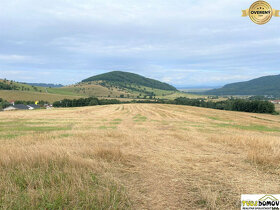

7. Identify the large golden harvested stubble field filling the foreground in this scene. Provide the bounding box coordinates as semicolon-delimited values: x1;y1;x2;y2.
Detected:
0;104;280;209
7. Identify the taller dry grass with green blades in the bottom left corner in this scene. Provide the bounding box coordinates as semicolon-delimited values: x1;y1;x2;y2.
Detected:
0;134;129;209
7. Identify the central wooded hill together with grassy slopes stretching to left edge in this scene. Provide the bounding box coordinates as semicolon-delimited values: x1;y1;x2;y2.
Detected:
0;71;198;102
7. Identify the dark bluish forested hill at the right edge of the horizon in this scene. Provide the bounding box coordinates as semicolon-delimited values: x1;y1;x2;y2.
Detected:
203;75;280;96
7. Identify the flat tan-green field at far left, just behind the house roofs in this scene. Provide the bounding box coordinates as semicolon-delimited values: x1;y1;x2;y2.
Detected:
0;90;81;103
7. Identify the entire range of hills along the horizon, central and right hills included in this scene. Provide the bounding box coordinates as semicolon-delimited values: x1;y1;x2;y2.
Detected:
4;71;280;101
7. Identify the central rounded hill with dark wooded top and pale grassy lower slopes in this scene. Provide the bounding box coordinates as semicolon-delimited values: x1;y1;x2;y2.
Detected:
53;71;197;99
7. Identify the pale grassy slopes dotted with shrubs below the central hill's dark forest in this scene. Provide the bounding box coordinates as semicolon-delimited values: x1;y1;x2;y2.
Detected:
0;80;201;103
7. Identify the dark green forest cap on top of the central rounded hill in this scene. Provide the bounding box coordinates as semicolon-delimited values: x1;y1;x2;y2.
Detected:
82;71;177;91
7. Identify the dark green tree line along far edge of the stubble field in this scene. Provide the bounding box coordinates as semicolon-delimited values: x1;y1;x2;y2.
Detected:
53;97;277;114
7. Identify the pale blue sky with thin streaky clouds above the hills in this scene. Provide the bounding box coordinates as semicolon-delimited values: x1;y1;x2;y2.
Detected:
0;0;280;87
